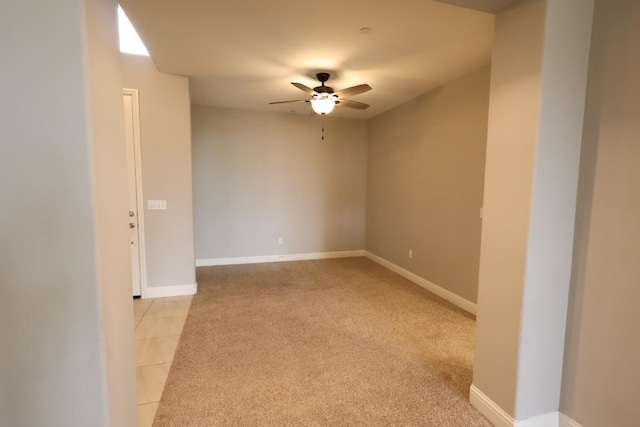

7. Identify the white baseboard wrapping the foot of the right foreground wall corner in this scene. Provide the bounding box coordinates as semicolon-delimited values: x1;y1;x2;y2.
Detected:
469;384;582;427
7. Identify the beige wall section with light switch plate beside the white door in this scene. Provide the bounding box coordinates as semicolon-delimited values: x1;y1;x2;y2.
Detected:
122;54;195;287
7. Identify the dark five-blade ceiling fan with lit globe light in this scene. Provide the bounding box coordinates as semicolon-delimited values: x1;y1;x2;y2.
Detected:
269;73;371;114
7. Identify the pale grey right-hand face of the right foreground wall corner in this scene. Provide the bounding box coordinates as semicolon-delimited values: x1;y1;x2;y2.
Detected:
515;0;593;420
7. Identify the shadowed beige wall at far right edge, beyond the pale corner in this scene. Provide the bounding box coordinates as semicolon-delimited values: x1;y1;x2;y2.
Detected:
561;0;640;427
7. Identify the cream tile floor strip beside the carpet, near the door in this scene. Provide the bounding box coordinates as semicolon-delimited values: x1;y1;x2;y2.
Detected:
133;296;192;427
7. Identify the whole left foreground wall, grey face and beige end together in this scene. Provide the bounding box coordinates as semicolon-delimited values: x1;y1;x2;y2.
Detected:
0;0;136;427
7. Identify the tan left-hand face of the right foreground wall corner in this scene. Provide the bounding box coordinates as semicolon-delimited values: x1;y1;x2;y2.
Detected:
473;0;546;416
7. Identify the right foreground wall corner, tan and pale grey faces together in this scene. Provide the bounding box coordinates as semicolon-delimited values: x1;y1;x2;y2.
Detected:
471;0;593;421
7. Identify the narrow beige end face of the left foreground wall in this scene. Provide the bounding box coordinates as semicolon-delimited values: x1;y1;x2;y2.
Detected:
85;0;138;426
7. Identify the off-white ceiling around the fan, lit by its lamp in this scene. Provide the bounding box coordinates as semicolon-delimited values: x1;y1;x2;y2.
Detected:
121;0;493;118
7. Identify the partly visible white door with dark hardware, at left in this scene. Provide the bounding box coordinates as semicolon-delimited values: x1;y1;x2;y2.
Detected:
123;89;144;297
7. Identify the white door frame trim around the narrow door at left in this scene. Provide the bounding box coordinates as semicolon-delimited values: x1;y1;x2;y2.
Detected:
122;88;147;299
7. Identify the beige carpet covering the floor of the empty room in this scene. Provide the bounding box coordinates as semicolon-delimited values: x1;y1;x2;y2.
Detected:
154;258;490;427
